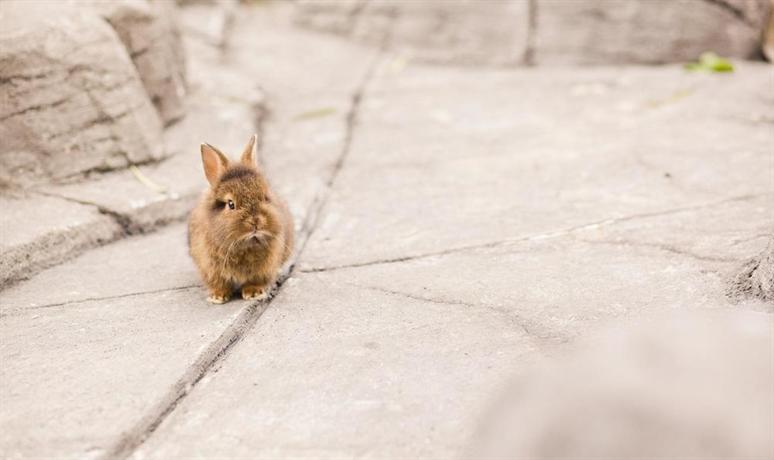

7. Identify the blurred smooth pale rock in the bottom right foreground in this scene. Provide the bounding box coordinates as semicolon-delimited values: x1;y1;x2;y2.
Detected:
466;313;774;459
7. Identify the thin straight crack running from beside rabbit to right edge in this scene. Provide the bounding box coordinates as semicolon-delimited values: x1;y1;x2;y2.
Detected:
299;193;772;273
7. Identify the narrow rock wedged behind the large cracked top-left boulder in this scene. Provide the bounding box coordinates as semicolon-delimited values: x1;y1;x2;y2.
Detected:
94;0;186;124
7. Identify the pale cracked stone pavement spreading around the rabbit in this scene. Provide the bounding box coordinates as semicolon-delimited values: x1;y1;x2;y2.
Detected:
0;1;774;459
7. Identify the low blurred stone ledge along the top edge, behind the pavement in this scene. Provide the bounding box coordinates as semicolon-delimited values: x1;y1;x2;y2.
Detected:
295;0;771;65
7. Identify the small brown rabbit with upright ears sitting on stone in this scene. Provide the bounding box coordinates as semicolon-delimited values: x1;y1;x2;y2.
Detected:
188;136;293;303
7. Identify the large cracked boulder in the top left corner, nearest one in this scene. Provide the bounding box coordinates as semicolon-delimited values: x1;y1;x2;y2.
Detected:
0;2;163;183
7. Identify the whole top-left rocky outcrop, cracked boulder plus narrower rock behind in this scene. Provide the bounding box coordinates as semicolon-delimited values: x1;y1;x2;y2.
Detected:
0;0;185;185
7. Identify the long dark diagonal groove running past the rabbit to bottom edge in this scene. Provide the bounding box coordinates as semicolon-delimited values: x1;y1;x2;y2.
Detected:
101;49;392;459
